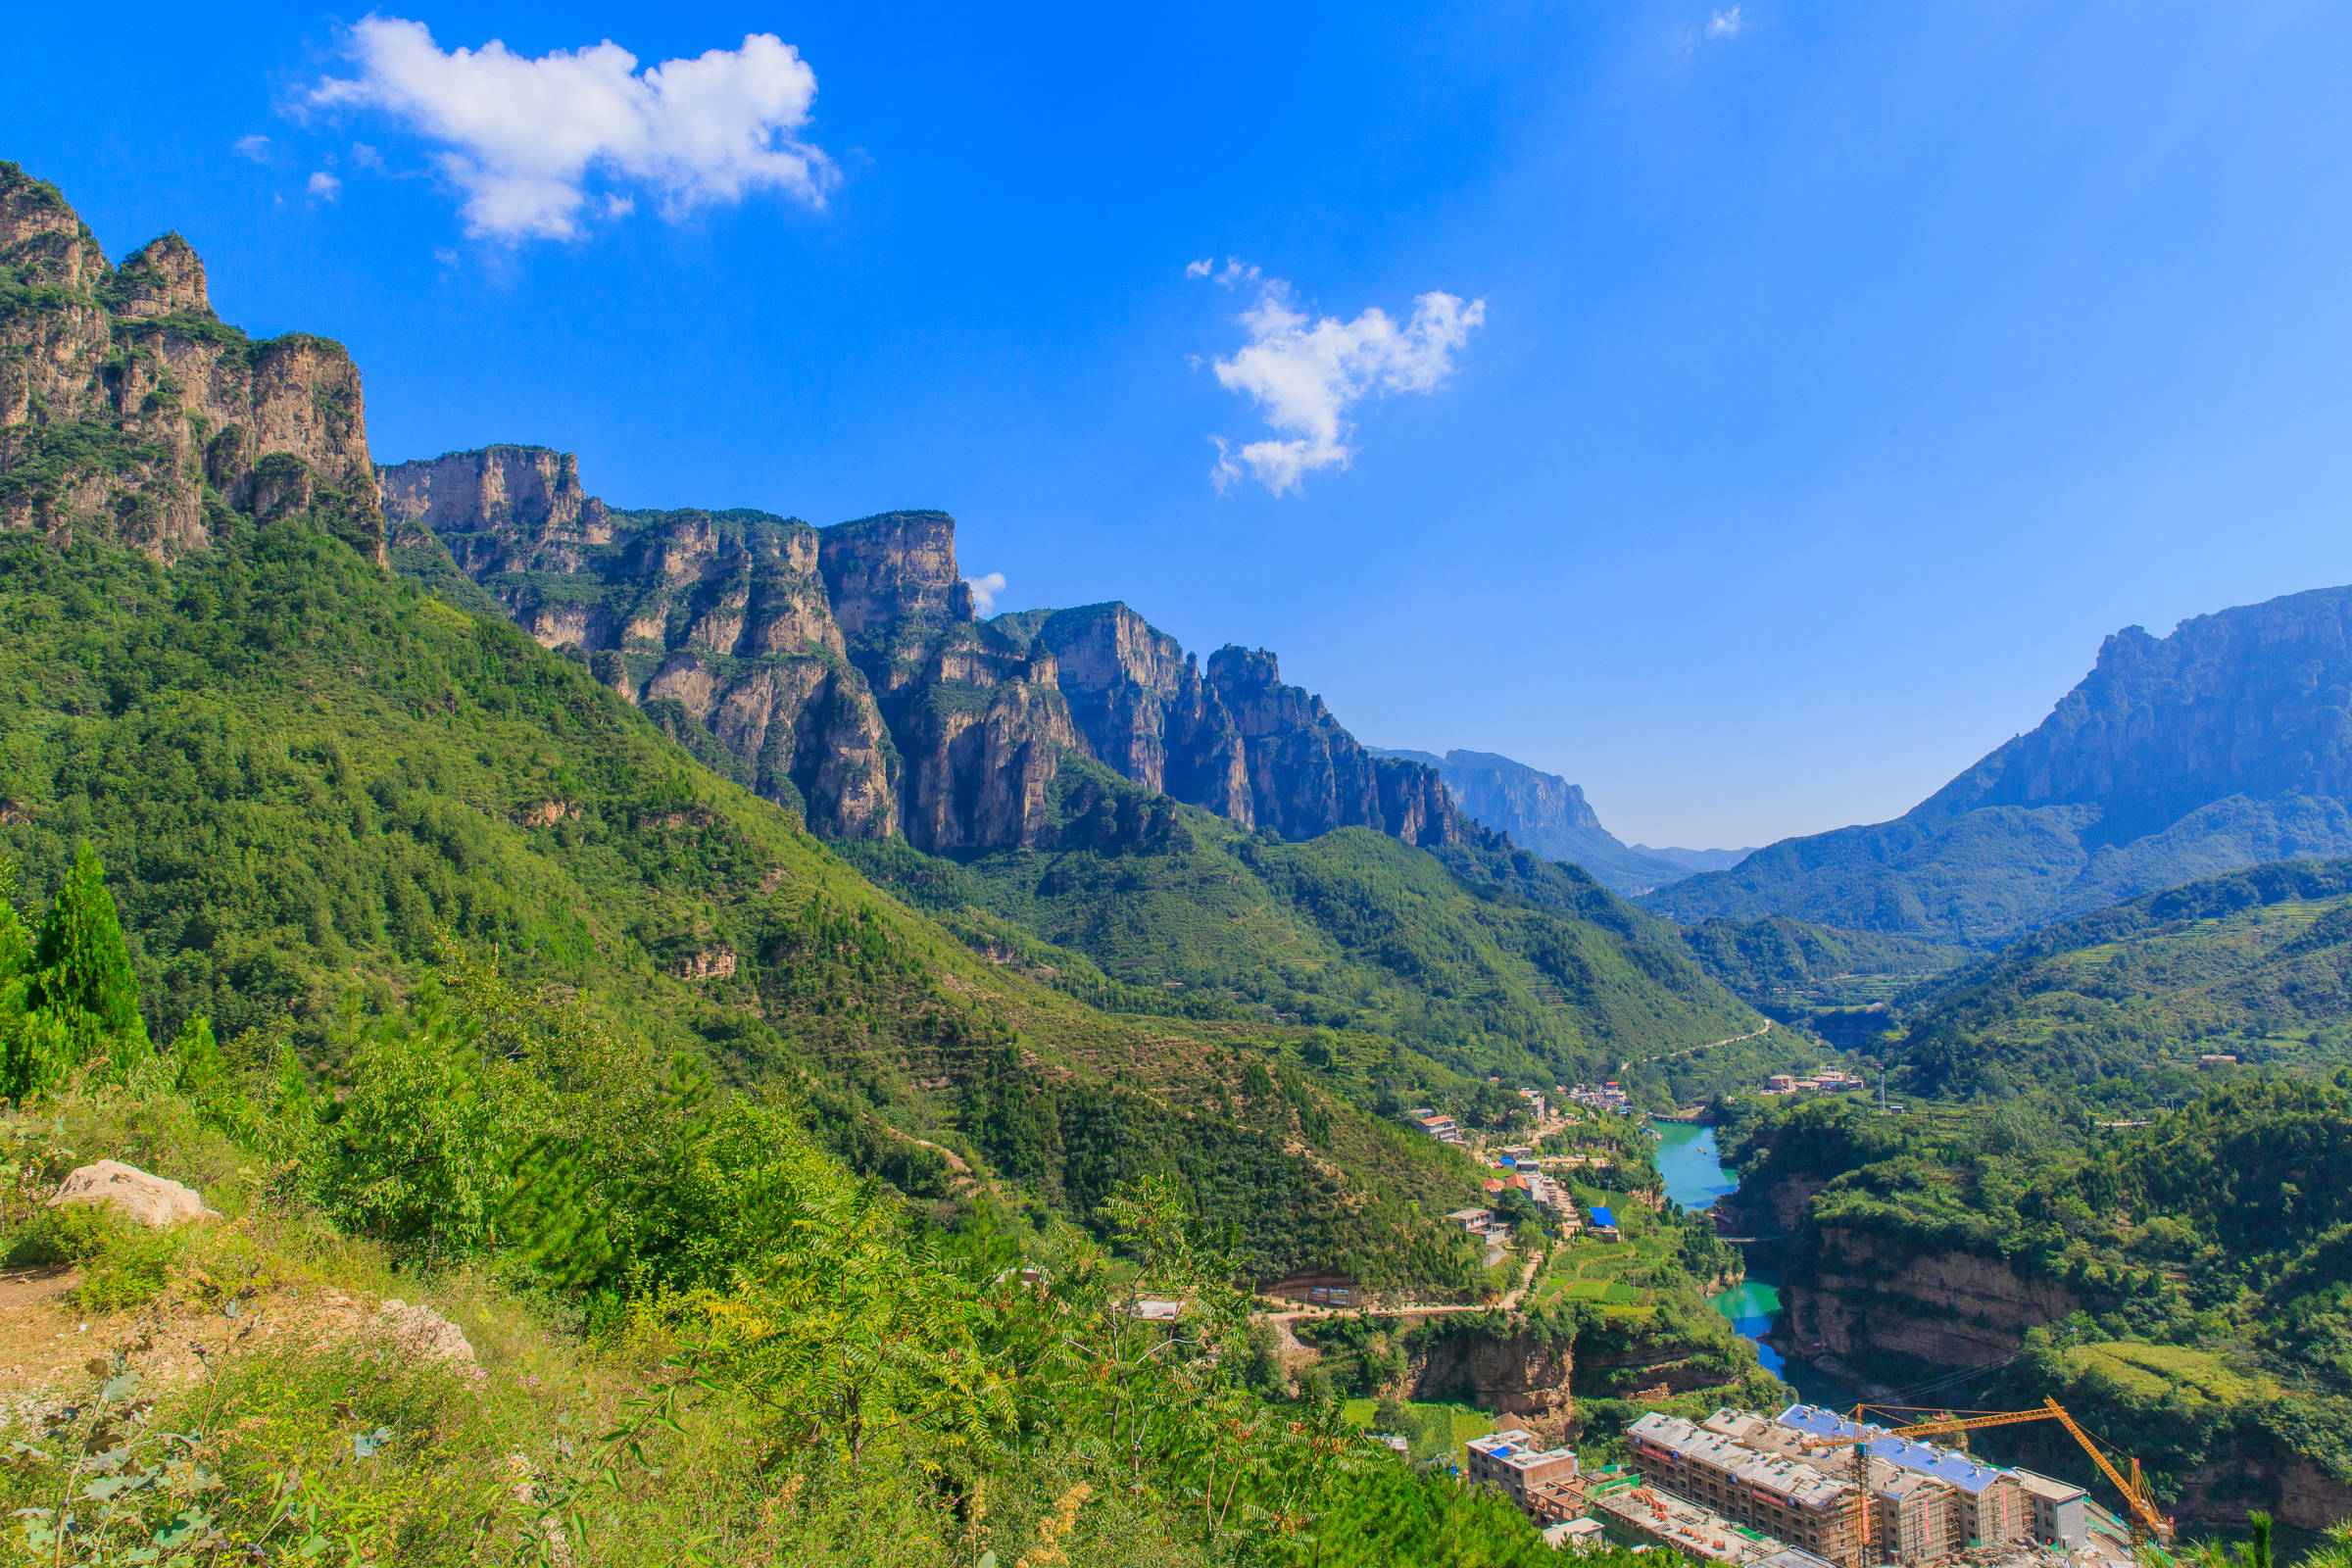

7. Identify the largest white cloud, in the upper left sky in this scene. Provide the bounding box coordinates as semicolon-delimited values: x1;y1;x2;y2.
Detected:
306;17;835;240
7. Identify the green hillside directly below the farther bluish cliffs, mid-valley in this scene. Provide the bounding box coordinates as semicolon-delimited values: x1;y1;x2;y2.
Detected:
840;760;1762;1104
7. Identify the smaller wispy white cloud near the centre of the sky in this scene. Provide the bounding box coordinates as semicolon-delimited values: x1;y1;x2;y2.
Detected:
1195;264;1487;496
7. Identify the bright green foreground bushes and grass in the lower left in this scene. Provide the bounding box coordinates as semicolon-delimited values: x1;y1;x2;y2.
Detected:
0;869;1633;1568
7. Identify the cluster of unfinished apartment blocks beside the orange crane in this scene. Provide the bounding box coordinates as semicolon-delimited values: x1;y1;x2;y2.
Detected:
1628;1405;2091;1568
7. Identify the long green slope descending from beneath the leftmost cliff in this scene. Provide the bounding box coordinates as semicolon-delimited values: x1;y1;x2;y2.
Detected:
0;514;1505;1284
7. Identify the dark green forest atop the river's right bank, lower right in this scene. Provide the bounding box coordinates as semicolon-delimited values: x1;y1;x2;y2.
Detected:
1722;1072;2352;1519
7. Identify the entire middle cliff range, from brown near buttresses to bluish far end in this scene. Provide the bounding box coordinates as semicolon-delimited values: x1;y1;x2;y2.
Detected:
378;447;1482;854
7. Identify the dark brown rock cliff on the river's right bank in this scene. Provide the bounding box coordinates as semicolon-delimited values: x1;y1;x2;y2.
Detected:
1781;1227;2098;1366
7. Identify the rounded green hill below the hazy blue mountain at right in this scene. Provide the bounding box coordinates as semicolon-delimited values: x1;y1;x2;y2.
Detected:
1886;860;2352;1104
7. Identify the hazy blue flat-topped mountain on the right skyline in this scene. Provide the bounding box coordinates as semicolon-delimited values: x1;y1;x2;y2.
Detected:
1646;588;2352;948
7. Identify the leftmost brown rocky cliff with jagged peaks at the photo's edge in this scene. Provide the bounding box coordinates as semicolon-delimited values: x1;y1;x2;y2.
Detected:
0;163;383;562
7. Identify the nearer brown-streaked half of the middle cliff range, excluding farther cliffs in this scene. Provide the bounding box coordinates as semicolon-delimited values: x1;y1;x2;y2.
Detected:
381;447;1077;851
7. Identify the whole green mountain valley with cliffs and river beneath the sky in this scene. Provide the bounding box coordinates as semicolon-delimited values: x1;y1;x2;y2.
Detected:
14;113;2352;1568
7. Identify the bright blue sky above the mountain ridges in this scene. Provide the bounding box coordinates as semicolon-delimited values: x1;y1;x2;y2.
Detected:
14;0;2352;844
